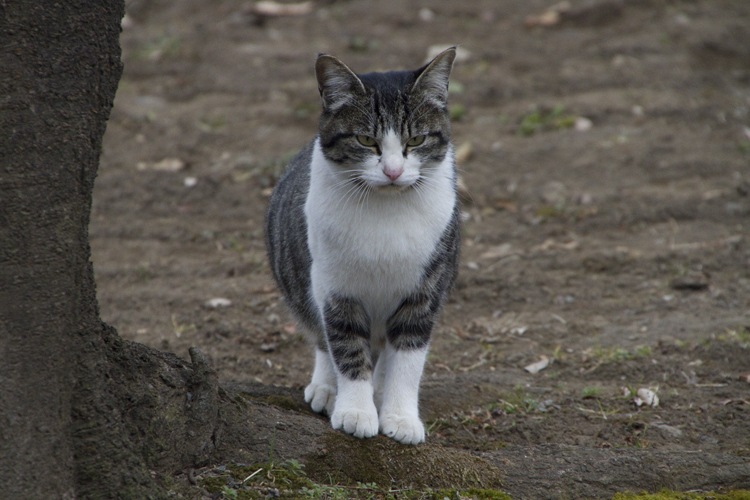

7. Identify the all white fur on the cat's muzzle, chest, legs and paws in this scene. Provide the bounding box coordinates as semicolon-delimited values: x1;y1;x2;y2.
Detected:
305;131;456;443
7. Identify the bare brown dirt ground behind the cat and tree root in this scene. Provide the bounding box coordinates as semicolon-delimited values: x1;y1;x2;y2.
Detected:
90;0;750;476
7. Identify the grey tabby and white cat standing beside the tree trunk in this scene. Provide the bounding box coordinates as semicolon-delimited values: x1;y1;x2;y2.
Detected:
265;48;460;444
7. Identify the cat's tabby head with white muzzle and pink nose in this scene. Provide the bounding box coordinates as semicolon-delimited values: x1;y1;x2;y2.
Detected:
315;48;456;191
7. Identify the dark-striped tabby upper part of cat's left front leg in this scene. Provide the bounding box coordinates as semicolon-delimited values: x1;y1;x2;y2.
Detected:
323;295;372;380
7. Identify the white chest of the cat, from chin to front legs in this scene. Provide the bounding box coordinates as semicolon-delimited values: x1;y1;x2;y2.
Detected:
305;139;455;321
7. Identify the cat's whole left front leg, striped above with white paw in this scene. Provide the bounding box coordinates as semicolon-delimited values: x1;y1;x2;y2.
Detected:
323;294;378;438
